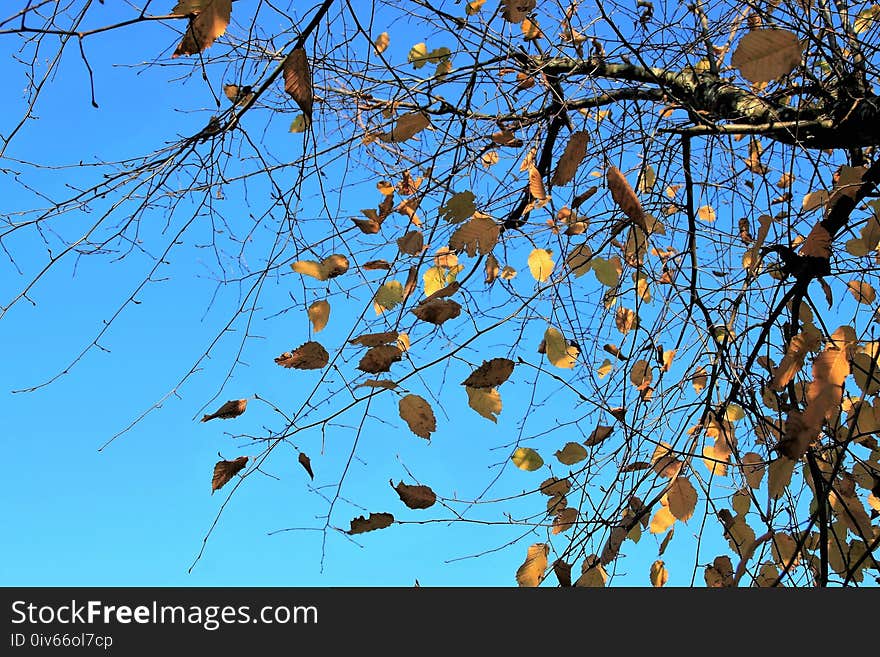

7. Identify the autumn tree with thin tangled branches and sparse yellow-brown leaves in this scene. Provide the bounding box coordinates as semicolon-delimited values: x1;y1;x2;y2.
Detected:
0;0;880;586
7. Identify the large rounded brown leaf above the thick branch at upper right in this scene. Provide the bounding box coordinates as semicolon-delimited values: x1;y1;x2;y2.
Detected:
730;29;803;84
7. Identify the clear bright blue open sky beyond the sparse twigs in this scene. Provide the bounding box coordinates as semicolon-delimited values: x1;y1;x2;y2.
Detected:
0;3;824;586
